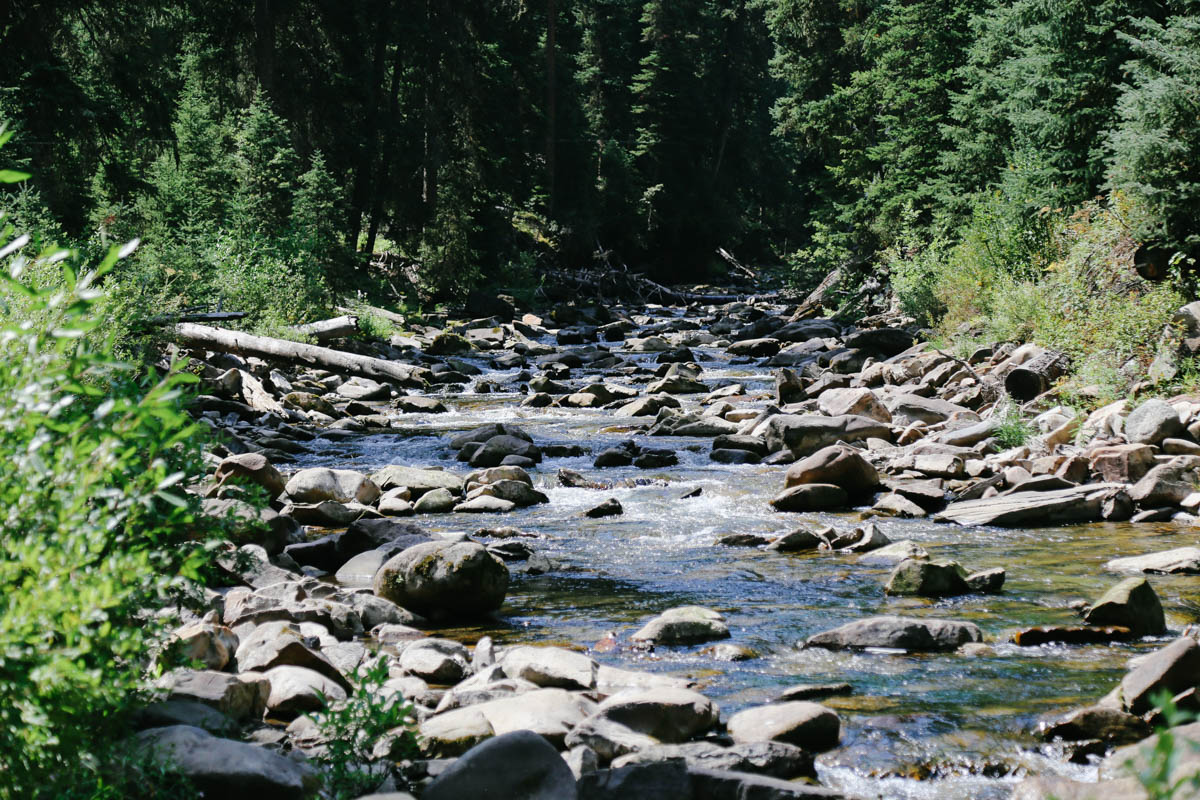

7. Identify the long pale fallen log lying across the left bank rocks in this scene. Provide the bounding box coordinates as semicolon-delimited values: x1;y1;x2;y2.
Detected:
175;323;428;389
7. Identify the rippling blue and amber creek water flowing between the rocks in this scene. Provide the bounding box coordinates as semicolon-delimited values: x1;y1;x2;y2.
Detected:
292;309;1200;799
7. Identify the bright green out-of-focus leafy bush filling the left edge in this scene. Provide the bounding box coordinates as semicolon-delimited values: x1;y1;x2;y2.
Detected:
0;221;218;799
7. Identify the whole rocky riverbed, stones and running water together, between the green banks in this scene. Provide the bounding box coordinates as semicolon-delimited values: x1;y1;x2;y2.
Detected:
139;297;1200;798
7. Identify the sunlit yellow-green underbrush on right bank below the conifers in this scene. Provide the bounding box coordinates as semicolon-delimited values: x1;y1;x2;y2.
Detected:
883;194;1187;403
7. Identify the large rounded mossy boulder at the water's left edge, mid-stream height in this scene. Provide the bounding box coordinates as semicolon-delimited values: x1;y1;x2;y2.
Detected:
374;541;509;619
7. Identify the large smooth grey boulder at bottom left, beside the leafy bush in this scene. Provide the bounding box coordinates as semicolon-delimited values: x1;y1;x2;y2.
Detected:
134;724;320;800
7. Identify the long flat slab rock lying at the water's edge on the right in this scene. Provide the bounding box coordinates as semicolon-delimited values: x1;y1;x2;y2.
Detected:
935;483;1124;528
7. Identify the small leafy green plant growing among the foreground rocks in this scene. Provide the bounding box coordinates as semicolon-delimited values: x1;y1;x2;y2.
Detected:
313;658;420;800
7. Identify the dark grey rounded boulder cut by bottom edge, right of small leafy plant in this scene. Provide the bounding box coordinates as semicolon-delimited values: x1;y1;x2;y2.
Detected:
421;730;576;800
